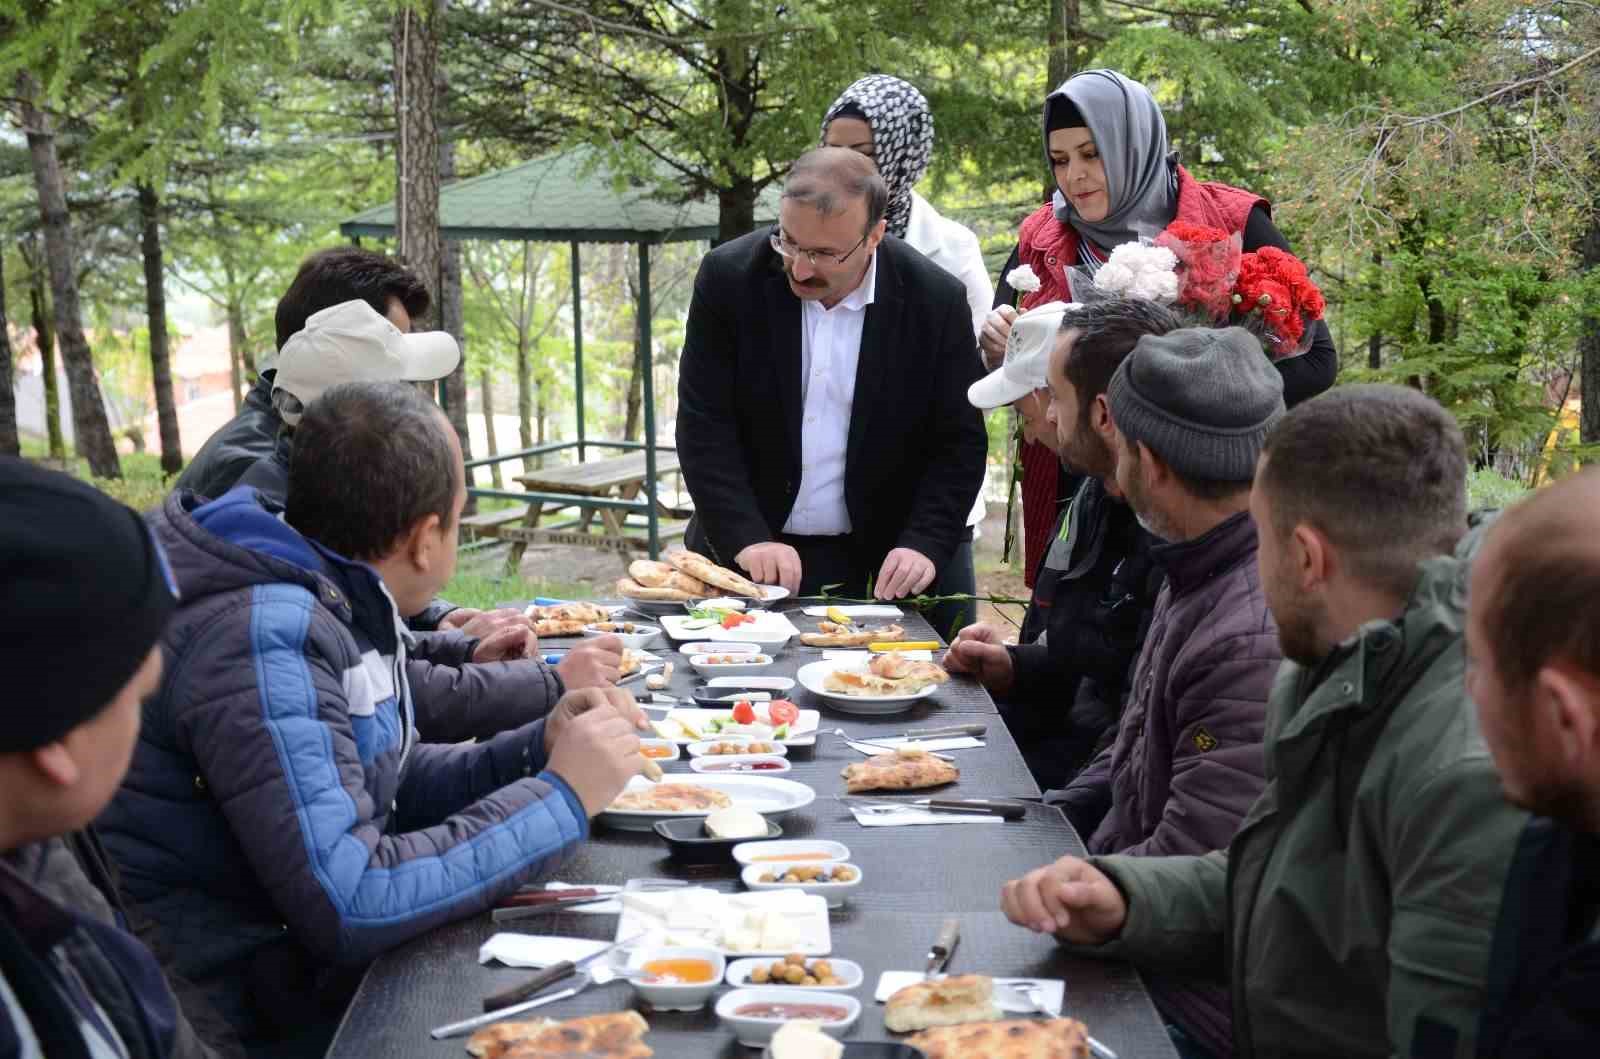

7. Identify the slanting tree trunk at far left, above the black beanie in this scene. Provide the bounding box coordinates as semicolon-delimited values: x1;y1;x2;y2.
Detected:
16;70;122;478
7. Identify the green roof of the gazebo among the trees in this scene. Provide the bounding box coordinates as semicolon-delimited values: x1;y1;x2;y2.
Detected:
339;147;778;243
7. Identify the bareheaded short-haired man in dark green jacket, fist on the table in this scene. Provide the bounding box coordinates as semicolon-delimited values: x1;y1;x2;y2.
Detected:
1003;386;1528;1059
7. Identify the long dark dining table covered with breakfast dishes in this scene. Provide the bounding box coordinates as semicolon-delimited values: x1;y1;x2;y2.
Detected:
328;606;1176;1059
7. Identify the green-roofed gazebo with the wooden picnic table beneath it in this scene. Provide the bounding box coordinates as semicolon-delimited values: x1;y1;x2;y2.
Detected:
339;147;778;566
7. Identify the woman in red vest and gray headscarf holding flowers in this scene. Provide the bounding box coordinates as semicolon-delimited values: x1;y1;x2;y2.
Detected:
979;70;1339;587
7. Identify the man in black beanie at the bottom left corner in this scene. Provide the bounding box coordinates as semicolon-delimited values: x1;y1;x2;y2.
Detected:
0;459;238;1059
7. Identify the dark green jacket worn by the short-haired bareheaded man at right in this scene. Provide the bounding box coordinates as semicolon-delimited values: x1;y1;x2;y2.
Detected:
1094;542;1528;1059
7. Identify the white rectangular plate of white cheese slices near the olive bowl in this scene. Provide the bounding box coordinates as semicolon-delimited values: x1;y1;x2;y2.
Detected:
616;886;834;957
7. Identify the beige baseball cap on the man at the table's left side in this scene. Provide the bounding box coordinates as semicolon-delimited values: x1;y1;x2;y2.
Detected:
272;299;461;426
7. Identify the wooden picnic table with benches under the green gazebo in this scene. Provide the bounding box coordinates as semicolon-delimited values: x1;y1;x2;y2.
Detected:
462;450;690;573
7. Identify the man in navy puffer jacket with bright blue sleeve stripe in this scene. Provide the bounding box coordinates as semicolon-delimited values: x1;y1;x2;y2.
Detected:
101;382;643;1049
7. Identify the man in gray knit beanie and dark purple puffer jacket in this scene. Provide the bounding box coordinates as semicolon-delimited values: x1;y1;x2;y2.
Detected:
1003;328;1283;1056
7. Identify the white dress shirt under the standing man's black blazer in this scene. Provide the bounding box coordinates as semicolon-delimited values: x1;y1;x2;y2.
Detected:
784;253;878;536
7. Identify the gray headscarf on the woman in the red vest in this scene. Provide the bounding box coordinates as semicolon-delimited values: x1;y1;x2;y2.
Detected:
1043;70;1178;250
